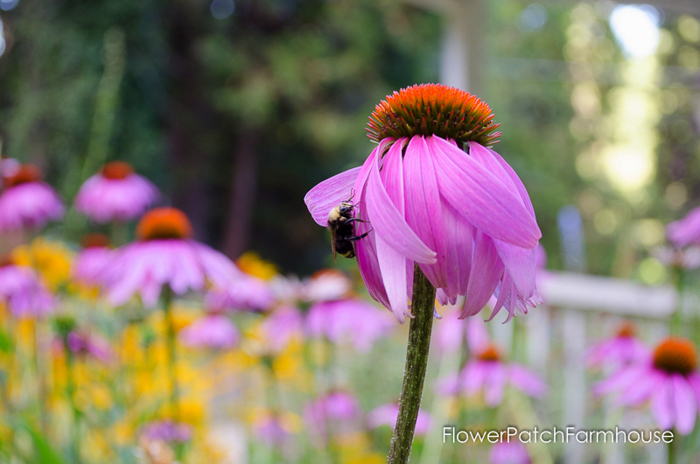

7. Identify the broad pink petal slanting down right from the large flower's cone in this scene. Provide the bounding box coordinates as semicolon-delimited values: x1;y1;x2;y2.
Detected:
428;136;542;248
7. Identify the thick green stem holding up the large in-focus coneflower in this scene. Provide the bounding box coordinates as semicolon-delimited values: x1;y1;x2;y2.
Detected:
388;264;435;464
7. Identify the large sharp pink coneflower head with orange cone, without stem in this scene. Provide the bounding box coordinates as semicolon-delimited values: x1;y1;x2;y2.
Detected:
304;84;541;321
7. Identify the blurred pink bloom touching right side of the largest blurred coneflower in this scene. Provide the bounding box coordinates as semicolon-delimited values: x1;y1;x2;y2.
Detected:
205;274;275;312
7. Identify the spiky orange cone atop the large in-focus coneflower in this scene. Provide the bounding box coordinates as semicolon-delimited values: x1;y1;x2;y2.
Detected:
367;84;501;146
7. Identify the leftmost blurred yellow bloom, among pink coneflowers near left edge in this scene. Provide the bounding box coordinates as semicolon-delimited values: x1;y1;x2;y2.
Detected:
12;237;73;292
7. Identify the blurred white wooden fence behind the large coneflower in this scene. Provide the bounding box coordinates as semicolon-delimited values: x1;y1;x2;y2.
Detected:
524;272;684;464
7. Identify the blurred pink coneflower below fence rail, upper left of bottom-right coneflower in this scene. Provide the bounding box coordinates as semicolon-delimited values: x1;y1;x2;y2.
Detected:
586;322;650;368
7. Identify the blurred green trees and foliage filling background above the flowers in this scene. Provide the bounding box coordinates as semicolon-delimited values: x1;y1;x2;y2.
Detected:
0;0;700;284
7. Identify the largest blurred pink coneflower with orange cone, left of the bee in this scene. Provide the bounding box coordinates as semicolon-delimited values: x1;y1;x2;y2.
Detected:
105;208;242;307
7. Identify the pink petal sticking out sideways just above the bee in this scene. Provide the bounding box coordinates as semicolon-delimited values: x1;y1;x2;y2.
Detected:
304;166;362;227
